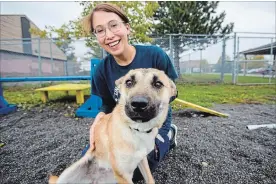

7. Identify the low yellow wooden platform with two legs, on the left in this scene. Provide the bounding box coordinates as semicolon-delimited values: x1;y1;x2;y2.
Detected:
35;84;91;104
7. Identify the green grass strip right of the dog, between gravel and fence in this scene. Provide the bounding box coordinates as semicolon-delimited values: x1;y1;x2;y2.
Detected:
173;84;276;109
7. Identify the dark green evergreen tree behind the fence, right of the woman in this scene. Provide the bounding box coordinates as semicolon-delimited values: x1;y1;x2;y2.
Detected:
152;1;234;77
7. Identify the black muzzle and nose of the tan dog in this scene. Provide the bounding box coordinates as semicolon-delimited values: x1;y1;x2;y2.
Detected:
125;96;159;122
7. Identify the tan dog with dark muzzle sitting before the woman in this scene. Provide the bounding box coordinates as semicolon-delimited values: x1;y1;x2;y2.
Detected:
49;69;176;184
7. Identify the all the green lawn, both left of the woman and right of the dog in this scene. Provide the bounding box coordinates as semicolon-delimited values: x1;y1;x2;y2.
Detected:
4;78;276;109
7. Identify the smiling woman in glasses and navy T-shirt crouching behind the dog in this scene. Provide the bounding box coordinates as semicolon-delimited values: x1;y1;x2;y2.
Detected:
83;3;177;181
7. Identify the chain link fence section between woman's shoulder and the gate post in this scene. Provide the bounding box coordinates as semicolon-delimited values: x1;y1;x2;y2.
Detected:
153;34;226;83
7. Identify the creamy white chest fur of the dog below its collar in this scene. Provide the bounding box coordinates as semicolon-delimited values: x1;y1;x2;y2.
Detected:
97;123;155;170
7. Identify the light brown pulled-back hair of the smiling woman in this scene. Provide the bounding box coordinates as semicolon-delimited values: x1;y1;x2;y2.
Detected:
82;3;129;34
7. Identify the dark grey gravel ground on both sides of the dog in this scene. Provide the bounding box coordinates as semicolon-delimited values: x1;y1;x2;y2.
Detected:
0;104;276;184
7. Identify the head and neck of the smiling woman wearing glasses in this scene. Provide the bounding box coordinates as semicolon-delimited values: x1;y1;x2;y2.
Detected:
84;4;135;63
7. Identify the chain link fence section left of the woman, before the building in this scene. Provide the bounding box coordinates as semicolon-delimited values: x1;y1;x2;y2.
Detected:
0;38;102;77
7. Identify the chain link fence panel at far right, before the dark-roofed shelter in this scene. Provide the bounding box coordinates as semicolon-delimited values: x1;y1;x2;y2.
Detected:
232;32;276;85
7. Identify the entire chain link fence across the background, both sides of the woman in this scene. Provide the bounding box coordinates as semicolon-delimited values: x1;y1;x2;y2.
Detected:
0;33;276;84
